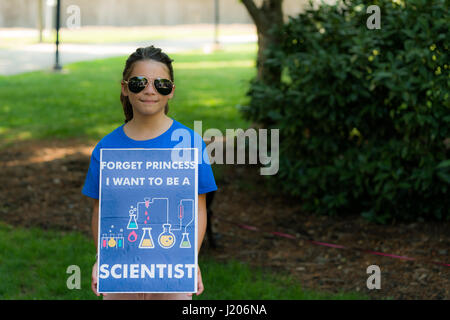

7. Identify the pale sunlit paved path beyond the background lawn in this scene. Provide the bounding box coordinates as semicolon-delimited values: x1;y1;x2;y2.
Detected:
0;36;257;75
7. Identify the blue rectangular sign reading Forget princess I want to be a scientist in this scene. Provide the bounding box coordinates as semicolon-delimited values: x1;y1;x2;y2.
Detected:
97;148;198;293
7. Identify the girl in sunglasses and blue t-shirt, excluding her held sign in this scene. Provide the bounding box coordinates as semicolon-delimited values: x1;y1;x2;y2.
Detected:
82;46;217;300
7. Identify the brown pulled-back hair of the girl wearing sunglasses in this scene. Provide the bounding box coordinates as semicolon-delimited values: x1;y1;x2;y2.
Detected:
120;45;174;123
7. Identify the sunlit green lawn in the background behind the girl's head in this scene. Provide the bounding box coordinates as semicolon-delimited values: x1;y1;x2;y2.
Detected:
0;44;256;148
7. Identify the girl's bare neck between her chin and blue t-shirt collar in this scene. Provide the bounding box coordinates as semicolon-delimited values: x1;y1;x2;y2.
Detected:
124;114;173;140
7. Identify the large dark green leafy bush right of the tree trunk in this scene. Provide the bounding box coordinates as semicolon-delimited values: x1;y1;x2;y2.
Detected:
241;0;450;223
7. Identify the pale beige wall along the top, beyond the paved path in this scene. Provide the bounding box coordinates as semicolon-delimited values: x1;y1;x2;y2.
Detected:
0;0;307;28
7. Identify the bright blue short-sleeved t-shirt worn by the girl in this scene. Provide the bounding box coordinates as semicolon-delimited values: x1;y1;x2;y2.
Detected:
81;119;217;199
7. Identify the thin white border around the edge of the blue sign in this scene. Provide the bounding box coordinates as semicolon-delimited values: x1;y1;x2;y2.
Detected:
97;148;199;293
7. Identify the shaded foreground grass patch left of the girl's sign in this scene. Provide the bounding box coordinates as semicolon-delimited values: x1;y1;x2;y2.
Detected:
0;223;96;299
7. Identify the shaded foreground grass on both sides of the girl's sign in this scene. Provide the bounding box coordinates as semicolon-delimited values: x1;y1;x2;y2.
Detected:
0;222;365;300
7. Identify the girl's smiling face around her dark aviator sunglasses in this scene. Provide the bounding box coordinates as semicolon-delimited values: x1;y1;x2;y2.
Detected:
122;60;175;116
